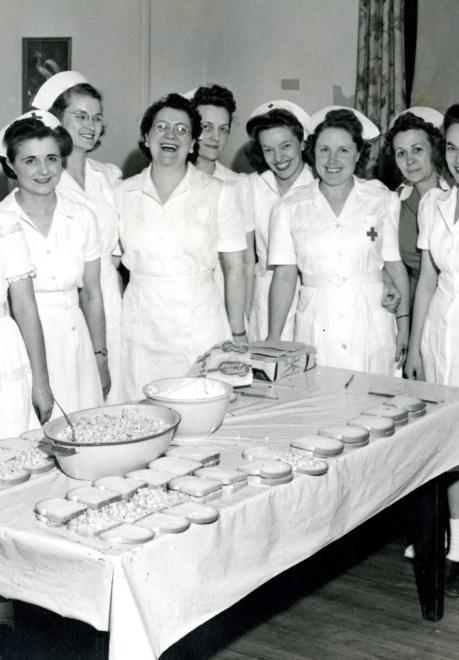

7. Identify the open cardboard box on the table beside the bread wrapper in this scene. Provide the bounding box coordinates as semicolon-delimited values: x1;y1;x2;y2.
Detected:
250;341;316;381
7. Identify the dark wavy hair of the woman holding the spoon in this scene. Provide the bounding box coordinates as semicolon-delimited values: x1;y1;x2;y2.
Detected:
1;117;73;179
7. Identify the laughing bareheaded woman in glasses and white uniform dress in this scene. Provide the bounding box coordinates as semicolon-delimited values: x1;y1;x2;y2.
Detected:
119;94;246;398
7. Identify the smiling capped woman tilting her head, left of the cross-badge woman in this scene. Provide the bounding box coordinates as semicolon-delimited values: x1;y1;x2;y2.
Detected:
243;100;313;341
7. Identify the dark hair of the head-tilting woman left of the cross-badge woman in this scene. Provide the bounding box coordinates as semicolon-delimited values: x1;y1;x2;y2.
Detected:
246;108;305;174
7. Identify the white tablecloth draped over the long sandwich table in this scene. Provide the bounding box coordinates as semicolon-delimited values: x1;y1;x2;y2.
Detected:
0;368;459;660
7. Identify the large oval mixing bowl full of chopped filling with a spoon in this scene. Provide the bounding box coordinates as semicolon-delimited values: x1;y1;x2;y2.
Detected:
43;403;180;481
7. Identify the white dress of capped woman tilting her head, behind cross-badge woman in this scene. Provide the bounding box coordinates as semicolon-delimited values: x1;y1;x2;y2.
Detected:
243;165;313;341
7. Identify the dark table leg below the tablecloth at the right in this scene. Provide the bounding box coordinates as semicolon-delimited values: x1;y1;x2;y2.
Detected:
414;476;446;621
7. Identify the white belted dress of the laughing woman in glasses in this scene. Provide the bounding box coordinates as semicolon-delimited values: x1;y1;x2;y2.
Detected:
118;165;246;399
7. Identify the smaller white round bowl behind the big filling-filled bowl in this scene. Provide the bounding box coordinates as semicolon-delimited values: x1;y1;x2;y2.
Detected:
143;378;233;437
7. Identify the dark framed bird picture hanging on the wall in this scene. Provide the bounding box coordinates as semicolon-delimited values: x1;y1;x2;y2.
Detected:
22;37;72;112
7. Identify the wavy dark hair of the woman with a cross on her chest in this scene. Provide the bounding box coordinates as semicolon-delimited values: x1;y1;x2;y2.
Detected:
305;108;371;177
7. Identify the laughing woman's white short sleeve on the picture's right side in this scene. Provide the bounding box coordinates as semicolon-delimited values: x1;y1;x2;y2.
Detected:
217;179;247;252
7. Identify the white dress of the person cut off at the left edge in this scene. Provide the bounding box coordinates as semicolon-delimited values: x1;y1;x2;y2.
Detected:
0;212;39;438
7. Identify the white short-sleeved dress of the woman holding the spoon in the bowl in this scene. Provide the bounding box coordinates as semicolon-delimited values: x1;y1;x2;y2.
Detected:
0;191;103;417
